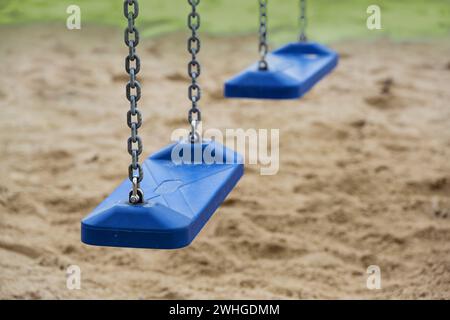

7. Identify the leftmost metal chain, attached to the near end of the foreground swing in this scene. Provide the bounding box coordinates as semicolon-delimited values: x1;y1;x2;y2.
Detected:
123;0;144;204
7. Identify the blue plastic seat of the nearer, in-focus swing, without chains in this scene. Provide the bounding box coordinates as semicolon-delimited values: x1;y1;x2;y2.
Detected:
81;141;244;249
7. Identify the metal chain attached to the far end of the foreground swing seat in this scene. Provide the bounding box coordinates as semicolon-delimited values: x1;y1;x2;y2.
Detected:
187;0;202;143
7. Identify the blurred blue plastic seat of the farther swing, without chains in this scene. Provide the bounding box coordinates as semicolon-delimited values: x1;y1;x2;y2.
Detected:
224;42;338;99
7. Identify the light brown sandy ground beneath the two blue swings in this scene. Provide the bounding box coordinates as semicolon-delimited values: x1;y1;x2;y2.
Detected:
0;26;450;299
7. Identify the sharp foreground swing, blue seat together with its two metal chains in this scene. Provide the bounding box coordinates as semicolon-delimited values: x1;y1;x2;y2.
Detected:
81;0;244;249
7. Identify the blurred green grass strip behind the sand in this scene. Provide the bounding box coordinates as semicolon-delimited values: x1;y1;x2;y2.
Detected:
0;0;450;43
